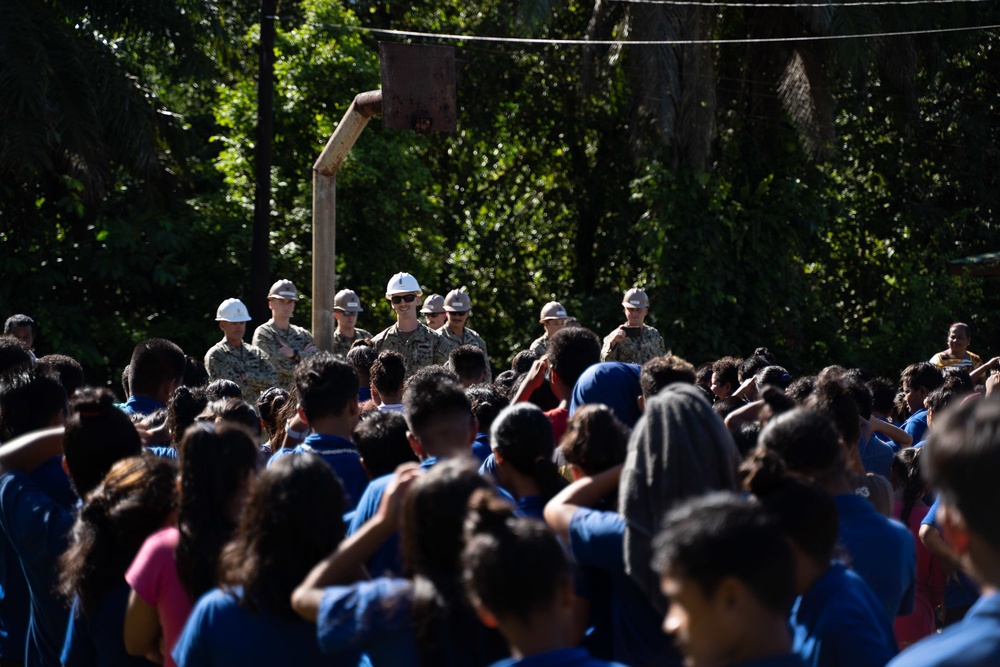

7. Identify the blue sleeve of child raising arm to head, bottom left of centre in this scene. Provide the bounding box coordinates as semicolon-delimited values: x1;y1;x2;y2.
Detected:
316;578;413;654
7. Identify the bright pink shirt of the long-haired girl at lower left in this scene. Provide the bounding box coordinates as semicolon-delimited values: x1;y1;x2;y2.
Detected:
125;528;194;667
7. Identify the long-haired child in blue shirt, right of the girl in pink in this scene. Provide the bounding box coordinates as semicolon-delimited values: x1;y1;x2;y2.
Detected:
173;454;358;667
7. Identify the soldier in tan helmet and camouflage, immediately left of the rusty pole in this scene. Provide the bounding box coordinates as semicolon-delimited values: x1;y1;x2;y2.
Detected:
253;280;319;389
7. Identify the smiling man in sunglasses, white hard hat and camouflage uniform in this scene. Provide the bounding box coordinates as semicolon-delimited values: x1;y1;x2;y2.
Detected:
372;273;447;377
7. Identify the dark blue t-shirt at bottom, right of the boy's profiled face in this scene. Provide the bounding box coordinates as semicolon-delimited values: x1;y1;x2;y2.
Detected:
789;563;897;667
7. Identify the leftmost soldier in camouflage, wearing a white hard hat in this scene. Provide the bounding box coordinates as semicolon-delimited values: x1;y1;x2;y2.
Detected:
205;299;278;405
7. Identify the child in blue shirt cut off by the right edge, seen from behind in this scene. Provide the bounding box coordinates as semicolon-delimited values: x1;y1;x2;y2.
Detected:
890;399;1000;667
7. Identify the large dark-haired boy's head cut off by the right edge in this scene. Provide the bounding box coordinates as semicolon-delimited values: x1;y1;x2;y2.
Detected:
921;399;1000;586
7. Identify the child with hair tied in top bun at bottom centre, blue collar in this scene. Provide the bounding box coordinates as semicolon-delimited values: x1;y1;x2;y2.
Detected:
462;488;623;667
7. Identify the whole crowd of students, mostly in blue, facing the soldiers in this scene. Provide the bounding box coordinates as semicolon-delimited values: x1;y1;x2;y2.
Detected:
0;314;1000;667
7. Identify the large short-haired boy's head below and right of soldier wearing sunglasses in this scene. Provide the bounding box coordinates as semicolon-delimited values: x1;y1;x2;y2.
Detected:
403;366;477;456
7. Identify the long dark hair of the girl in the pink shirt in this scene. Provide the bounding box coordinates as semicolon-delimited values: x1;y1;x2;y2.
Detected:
177;422;257;600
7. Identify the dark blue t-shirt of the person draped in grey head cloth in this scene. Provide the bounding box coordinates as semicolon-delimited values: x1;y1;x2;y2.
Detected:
569;508;684;667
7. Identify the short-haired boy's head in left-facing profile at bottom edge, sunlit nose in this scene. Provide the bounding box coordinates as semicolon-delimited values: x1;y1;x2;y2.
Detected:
653;493;795;666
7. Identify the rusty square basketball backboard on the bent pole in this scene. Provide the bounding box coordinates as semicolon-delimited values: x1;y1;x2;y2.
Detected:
378;42;457;132
